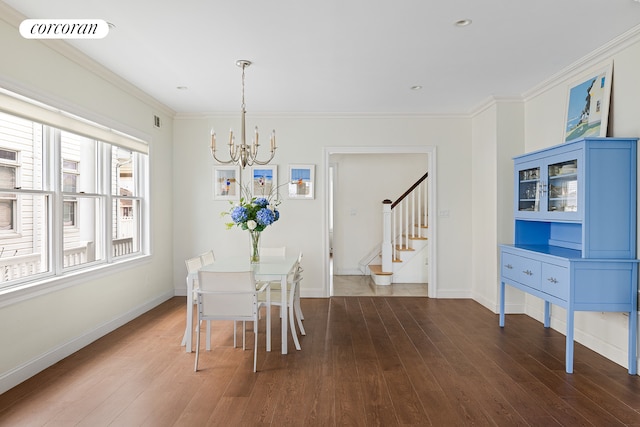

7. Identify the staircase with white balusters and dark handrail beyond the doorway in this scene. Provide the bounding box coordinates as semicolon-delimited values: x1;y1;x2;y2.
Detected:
364;172;429;285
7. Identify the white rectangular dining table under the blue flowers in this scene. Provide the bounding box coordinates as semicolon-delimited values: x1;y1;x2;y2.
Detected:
182;256;298;354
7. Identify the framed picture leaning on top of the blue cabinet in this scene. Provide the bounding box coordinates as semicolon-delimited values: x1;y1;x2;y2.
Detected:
563;62;613;142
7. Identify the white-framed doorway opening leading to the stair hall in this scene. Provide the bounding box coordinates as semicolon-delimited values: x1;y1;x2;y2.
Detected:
323;146;437;297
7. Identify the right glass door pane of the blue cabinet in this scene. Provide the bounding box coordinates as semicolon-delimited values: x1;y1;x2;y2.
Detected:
547;159;578;212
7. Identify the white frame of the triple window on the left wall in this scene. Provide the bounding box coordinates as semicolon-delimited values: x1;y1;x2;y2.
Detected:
0;88;150;300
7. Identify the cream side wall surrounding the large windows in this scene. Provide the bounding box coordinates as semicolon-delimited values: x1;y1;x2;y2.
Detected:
0;10;173;393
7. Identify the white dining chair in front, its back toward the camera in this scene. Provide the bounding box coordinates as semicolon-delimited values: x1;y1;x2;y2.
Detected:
194;270;270;372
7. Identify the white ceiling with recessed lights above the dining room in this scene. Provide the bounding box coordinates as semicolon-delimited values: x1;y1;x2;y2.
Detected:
1;0;640;114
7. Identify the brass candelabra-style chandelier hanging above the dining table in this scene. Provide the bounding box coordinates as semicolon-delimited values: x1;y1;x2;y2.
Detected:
211;59;276;169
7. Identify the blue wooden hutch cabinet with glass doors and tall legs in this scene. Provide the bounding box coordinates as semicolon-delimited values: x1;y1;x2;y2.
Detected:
500;138;638;374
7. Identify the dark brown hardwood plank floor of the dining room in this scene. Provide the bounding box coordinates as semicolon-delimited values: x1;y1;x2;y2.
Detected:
0;297;640;427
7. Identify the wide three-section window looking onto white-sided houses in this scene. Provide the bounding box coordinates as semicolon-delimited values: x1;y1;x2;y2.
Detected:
0;100;148;288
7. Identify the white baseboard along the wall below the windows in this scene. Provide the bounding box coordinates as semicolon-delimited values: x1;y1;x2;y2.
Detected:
0;291;174;394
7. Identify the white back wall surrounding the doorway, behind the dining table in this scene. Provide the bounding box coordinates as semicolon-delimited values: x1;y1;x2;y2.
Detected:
174;115;471;297
